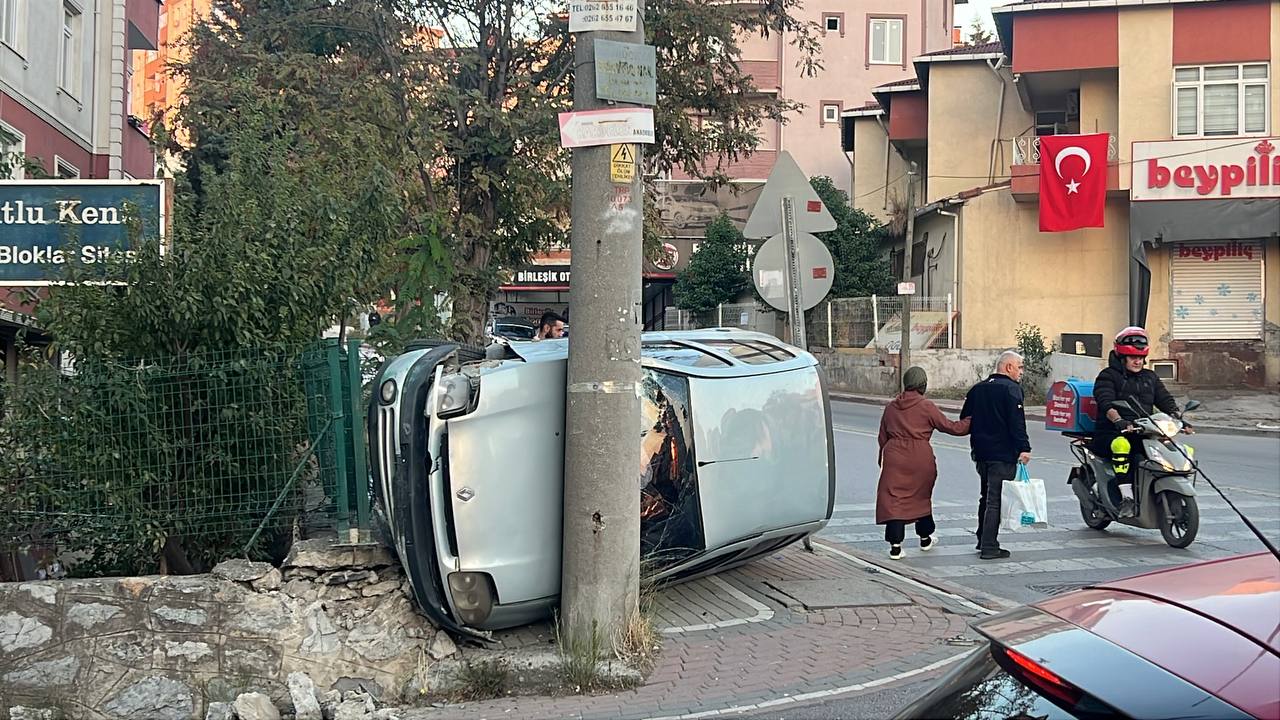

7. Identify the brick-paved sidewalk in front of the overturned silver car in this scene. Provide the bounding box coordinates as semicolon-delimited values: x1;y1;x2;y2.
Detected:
404;539;988;720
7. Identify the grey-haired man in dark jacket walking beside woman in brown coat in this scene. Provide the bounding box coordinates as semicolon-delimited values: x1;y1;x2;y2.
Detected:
960;350;1032;560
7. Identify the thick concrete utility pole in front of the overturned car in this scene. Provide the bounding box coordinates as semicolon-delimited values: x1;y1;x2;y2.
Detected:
559;0;644;651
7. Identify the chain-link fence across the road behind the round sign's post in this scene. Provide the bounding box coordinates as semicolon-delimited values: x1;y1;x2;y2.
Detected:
664;295;955;352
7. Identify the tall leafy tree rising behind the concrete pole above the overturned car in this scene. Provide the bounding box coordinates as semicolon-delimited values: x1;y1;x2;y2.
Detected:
172;0;818;341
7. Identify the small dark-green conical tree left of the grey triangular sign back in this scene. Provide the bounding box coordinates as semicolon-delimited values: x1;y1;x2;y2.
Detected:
676;214;751;313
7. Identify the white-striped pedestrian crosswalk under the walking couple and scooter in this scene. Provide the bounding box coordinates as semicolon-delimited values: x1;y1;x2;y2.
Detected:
820;486;1280;601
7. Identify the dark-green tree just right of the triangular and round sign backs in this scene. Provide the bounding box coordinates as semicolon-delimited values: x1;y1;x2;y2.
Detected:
809;177;895;297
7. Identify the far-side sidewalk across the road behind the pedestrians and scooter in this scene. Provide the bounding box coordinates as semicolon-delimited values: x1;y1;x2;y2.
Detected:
831;391;1280;437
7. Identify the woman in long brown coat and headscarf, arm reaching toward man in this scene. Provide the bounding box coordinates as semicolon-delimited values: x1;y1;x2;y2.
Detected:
876;368;969;560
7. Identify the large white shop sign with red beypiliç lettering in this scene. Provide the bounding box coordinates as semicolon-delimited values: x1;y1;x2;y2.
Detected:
1130;137;1280;201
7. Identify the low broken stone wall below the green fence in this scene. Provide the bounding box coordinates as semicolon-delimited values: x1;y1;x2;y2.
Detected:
0;541;460;720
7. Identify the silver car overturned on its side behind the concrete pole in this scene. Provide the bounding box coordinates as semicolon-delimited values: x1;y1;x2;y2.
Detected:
369;329;835;633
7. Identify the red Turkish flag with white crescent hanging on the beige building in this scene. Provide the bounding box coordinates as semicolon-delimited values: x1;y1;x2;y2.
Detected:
1039;132;1108;232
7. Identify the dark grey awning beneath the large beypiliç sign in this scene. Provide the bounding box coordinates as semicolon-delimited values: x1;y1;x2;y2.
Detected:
1129;197;1280;325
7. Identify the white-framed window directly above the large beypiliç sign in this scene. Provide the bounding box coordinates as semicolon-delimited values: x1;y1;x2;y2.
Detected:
1172;63;1271;137
